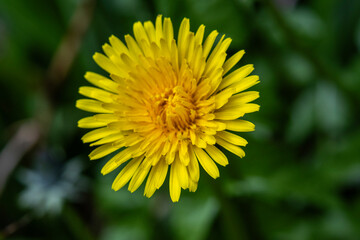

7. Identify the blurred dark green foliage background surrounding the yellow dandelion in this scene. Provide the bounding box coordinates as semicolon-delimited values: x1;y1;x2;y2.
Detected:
0;0;360;240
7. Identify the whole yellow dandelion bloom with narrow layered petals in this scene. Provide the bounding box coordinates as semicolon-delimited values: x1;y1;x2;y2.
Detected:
76;16;259;202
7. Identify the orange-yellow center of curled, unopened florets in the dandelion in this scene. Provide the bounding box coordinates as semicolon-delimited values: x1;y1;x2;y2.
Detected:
155;86;196;131
